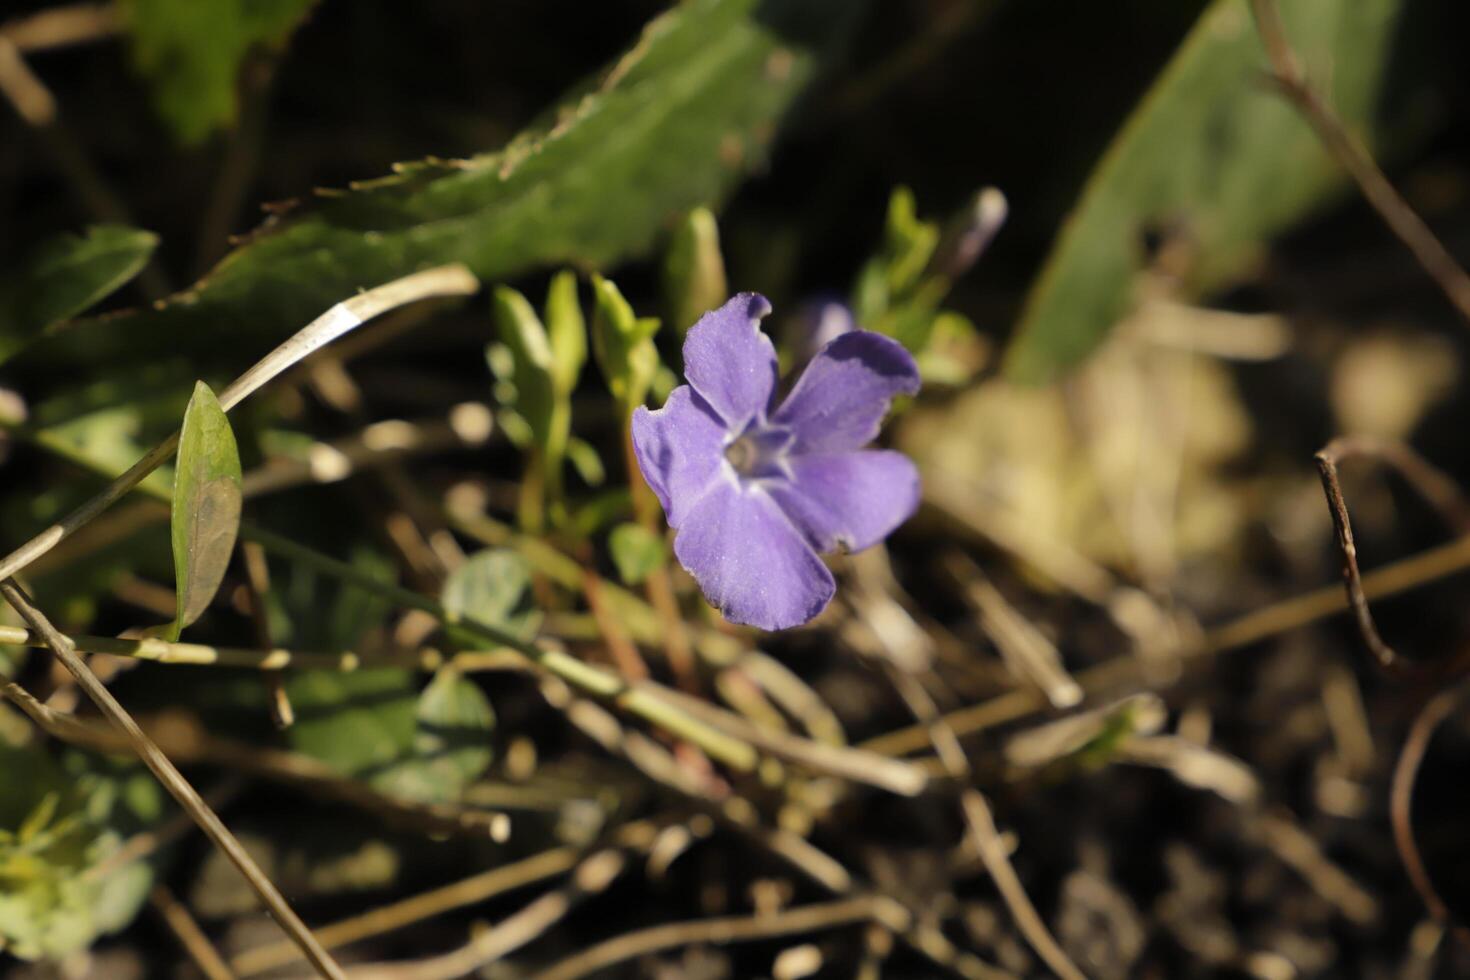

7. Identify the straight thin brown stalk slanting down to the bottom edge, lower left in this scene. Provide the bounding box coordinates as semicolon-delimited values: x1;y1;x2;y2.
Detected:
0;579;345;980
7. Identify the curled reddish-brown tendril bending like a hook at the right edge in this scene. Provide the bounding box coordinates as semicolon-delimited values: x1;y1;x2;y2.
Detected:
1313;439;1470;677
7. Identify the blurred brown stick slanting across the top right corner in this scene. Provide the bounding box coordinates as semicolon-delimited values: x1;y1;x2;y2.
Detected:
1251;0;1470;329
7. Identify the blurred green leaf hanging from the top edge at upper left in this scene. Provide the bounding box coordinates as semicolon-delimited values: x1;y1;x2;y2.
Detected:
119;0;316;144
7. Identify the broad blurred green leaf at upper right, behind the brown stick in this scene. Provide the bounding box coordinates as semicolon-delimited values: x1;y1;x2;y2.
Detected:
1007;0;1404;382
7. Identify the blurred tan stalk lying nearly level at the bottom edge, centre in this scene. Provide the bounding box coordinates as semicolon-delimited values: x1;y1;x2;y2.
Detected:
535;896;908;980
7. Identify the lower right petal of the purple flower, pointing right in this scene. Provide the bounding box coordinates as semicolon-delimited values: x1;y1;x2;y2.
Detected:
769;450;919;551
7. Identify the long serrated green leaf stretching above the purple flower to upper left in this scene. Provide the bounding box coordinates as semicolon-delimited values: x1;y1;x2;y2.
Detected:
48;0;866;371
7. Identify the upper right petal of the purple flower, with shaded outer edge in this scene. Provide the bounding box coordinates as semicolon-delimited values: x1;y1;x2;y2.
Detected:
772;331;919;453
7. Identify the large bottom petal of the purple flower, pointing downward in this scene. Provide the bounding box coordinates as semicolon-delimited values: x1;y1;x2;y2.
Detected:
673;480;836;629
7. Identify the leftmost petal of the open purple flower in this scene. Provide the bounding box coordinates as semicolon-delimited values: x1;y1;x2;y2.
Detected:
632;385;728;527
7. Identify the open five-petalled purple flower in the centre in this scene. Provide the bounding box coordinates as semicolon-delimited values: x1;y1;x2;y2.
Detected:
634;292;919;629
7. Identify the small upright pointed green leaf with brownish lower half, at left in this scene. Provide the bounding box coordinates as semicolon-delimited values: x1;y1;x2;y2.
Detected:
168;382;244;639
